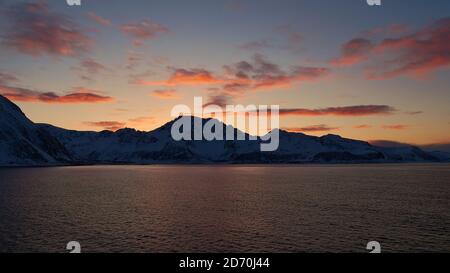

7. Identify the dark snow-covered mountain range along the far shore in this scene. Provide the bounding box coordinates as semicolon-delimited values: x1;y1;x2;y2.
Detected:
0;95;448;166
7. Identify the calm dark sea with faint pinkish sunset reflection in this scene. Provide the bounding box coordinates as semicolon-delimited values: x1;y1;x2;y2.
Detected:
0;164;450;252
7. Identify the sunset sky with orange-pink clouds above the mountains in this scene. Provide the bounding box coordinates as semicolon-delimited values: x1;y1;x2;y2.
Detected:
0;0;450;144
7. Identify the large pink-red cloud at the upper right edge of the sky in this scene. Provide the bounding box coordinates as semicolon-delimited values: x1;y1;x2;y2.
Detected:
331;17;450;79
